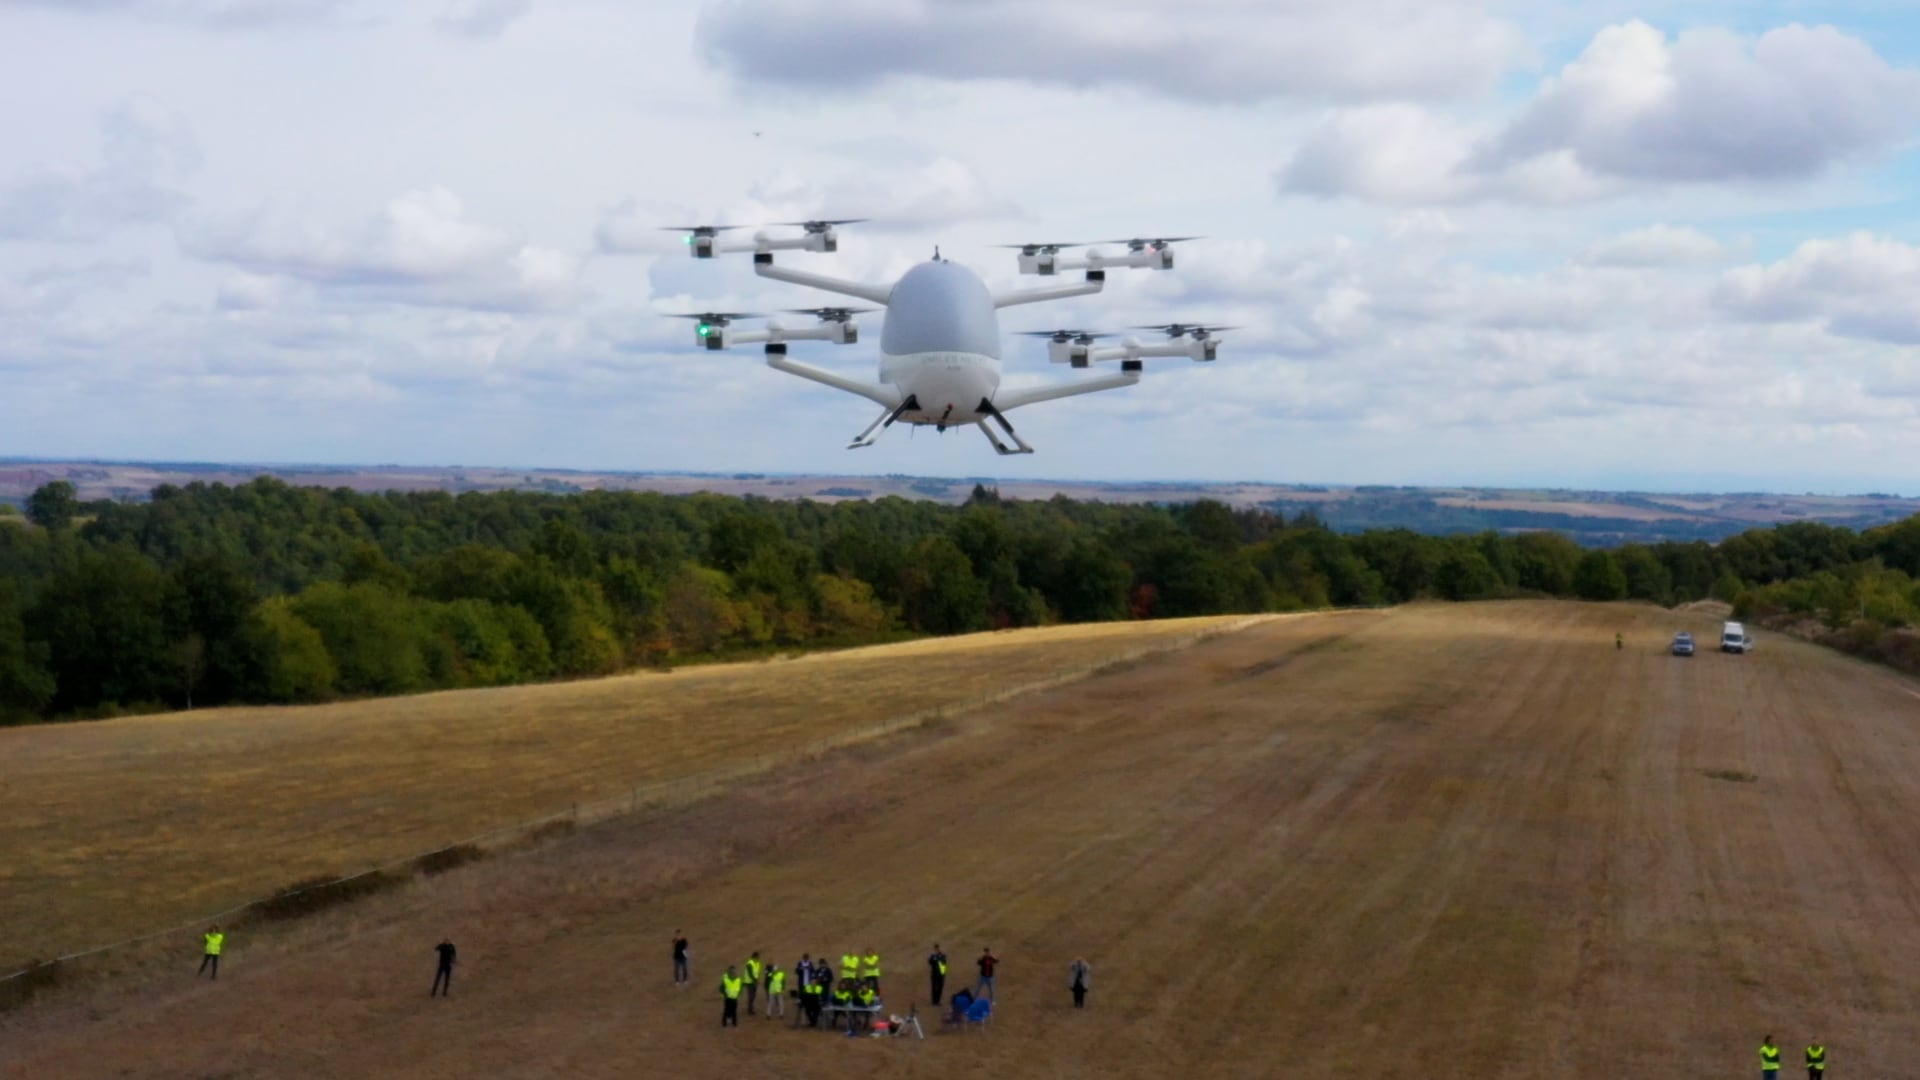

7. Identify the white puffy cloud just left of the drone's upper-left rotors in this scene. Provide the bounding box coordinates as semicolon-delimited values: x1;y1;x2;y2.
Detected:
184;188;580;311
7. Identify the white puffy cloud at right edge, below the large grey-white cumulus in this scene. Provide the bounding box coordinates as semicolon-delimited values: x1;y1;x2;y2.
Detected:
1715;233;1920;346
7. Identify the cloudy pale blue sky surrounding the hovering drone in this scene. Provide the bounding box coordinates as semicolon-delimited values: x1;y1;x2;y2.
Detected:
0;0;1920;494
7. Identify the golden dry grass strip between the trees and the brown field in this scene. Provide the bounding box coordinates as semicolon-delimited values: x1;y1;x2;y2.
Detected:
0;619;1236;970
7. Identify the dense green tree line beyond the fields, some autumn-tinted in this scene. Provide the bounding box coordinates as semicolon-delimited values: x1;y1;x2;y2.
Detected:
0;477;1920;723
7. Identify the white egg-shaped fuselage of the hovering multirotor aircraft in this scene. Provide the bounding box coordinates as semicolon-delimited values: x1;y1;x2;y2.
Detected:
879;259;1000;427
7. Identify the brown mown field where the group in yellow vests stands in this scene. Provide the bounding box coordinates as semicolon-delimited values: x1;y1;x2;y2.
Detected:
0;603;1920;1080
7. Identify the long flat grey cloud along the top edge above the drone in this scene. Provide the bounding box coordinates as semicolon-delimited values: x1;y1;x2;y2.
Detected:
695;0;1523;102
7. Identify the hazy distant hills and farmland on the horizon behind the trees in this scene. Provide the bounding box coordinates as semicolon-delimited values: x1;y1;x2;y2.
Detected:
0;459;1920;546
